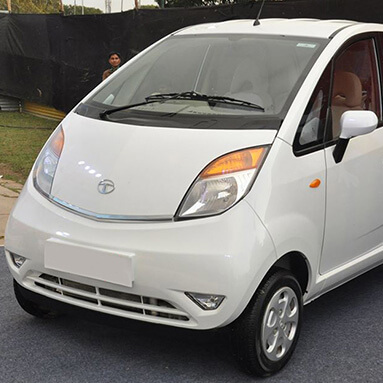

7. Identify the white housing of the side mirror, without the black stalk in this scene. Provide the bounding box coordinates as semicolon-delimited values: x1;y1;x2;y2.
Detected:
339;110;378;139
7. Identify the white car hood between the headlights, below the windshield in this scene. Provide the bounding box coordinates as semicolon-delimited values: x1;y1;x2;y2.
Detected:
51;113;277;220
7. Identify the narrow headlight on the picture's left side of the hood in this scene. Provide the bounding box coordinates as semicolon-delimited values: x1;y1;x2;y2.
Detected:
33;125;64;197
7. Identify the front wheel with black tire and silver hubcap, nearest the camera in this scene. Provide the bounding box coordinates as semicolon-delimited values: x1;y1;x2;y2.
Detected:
232;269;303;377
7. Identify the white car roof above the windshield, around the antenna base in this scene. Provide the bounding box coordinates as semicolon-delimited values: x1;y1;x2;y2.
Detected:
176;19;360;38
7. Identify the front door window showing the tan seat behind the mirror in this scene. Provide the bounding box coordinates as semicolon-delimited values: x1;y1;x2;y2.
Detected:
329;38;380;140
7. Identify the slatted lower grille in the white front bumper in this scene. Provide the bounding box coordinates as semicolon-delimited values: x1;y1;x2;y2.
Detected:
27;274;189;321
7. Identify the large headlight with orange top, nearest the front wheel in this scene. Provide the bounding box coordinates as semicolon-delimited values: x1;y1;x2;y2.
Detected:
176;146;269;219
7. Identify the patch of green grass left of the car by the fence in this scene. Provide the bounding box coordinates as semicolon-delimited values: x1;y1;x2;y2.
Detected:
0;112;59;183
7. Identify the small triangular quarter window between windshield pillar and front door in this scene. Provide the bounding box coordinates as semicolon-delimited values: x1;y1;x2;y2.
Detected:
293;64;331;155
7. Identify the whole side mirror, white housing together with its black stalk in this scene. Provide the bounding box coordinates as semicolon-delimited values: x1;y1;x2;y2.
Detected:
333;110;378;163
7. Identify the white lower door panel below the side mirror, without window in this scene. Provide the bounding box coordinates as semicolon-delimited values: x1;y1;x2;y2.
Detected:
320;124;383;274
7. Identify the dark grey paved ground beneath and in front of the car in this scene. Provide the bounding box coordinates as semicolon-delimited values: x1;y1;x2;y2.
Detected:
0;247;383;383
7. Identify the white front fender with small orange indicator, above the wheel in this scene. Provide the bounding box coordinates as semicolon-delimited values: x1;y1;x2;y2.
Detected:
246;139;326;297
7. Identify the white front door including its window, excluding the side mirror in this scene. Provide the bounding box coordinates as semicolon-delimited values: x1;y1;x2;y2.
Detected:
320;38;383;274
